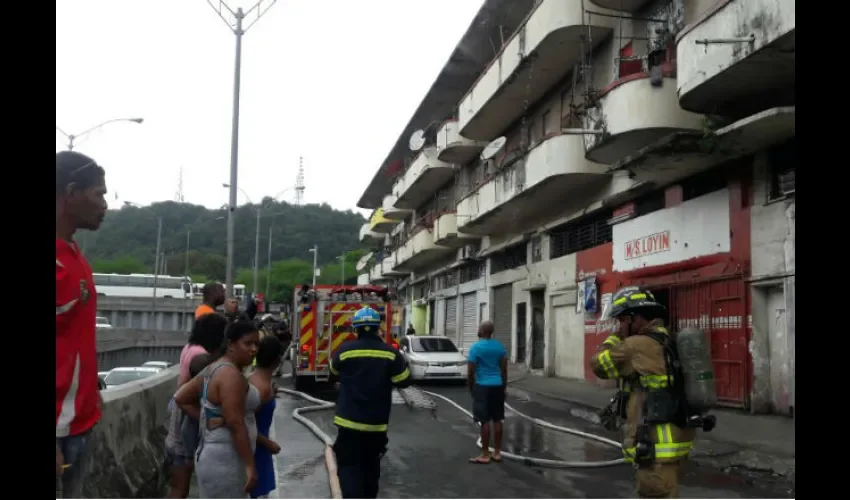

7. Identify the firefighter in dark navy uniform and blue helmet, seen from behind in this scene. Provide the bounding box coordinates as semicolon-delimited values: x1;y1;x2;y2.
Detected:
330;307;410;498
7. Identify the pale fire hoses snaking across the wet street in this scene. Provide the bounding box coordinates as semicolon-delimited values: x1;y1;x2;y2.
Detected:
277;374;626;498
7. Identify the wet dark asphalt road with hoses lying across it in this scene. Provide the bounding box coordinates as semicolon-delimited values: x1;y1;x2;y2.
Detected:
273;380;795;498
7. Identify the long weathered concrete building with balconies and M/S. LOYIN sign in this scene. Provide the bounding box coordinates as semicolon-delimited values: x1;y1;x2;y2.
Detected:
358;0;796;412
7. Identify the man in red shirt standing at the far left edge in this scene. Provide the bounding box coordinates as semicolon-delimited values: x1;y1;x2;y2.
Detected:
56;151;106;498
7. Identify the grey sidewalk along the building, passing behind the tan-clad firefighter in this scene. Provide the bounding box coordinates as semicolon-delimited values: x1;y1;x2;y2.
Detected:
508;365;795;482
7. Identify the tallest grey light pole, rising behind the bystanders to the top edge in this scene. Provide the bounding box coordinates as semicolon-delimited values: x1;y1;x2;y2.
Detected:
207;0;276;296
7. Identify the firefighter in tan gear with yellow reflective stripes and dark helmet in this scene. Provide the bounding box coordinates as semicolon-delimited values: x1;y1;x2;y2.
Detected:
590;286;695;498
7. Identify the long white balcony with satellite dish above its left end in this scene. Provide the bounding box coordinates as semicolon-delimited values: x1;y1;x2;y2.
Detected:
457;134;609;236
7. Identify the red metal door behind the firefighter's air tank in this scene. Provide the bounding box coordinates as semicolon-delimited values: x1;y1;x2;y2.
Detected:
670;276;750;408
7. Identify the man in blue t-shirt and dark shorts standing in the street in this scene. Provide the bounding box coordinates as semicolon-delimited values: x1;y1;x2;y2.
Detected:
467;321;508;464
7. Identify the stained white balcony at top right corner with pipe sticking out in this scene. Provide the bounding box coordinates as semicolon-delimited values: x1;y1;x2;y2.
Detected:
676;0;796;116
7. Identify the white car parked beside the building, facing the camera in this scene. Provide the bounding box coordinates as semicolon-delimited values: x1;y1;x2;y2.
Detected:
399;335;466;381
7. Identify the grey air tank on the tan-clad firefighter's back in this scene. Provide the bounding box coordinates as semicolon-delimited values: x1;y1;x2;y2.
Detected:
676;328;717;413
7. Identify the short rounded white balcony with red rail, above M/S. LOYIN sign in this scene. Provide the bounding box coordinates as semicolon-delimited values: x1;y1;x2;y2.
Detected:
584;73;703;165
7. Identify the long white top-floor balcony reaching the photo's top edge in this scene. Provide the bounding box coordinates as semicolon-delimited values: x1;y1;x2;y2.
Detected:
458;0;617;141
